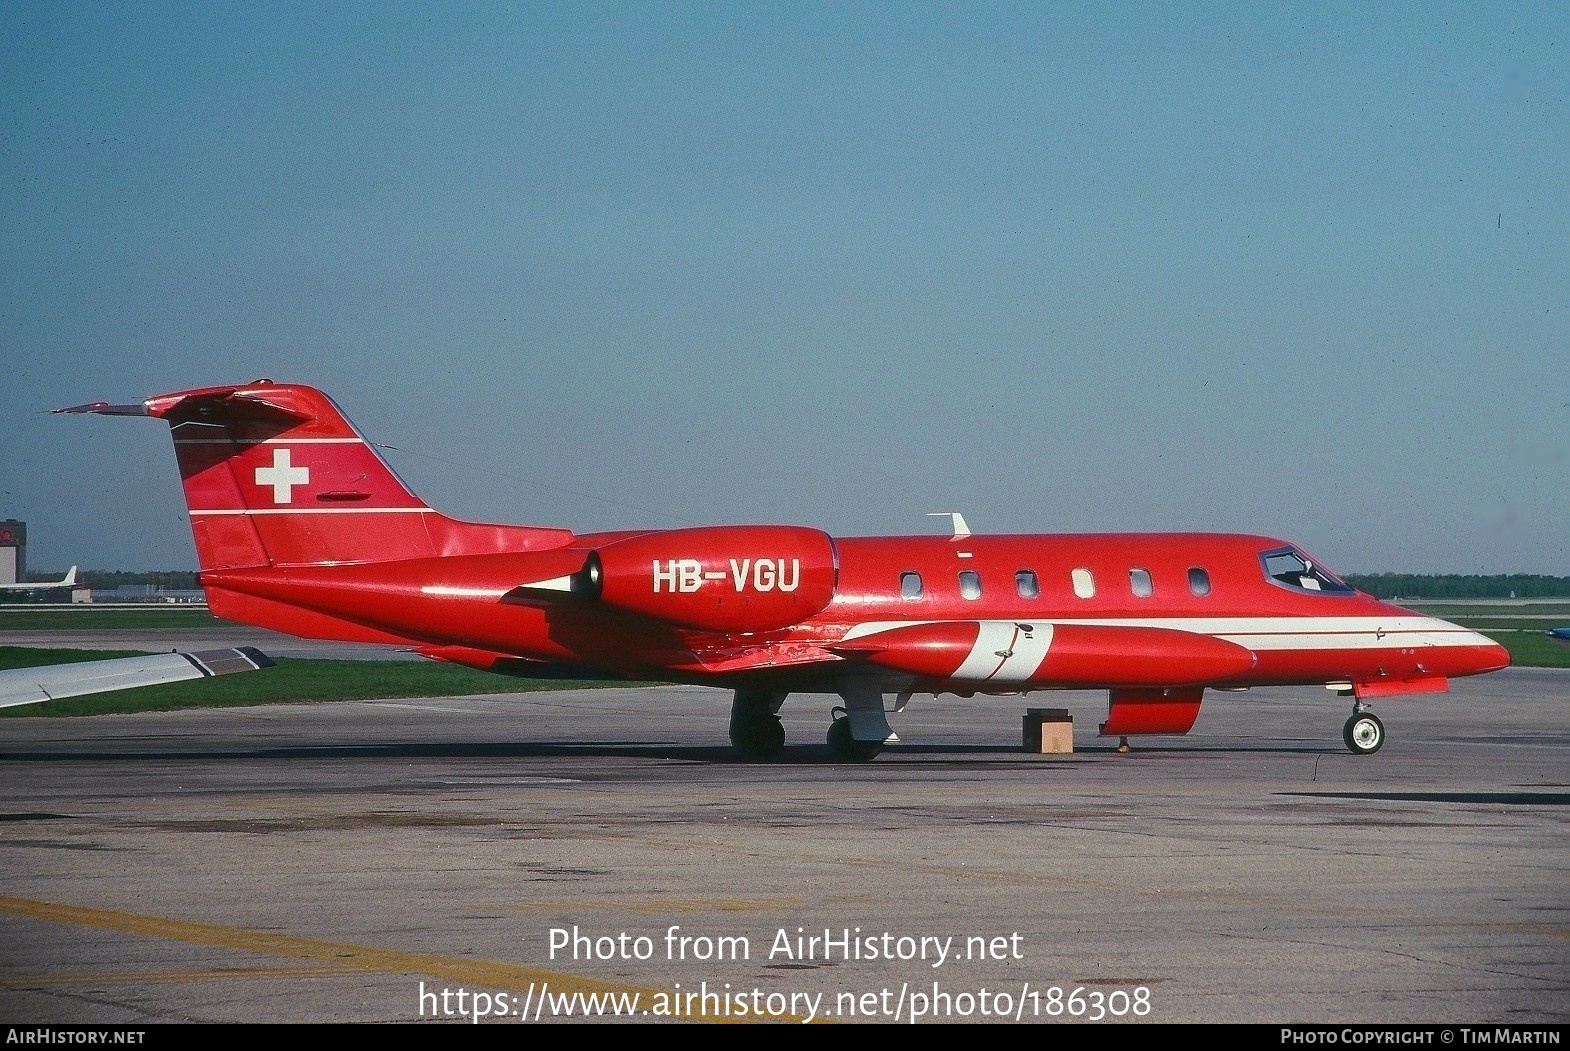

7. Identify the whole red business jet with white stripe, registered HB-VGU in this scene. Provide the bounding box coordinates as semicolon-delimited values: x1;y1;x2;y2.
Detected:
58;380;1510;759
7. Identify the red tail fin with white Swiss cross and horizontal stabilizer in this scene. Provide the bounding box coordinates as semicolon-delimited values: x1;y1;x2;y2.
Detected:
60;380;571;570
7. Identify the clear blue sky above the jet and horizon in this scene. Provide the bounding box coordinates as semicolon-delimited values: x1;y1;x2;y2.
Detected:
0;2;1570;575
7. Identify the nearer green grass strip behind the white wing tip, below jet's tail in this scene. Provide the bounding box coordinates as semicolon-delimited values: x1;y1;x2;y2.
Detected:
0;647;642;718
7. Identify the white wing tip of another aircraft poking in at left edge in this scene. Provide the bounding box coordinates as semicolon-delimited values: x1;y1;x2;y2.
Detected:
0;646;273;709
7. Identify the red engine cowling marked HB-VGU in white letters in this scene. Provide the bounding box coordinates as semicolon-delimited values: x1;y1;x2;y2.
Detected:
573;526;838;632
